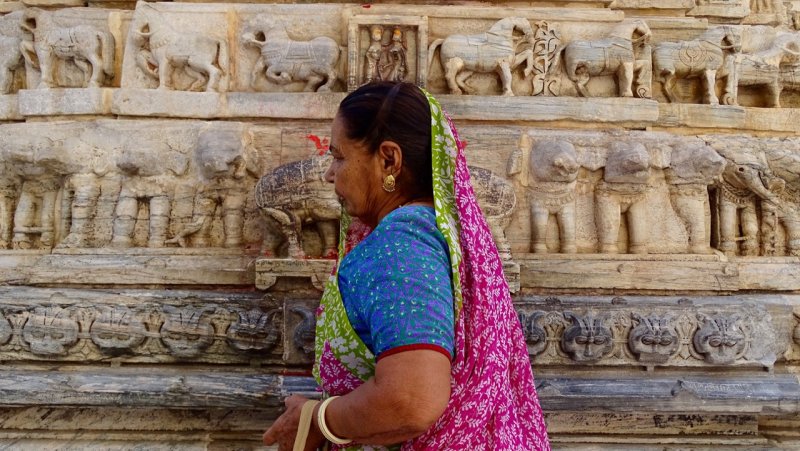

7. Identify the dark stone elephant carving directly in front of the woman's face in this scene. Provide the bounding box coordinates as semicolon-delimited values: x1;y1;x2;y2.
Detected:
256;154;342;258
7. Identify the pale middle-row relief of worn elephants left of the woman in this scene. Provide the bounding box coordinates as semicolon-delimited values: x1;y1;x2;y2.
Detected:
0;121;263;252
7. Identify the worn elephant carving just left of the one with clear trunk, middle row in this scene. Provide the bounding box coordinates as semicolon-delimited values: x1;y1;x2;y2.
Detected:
664;143;725;254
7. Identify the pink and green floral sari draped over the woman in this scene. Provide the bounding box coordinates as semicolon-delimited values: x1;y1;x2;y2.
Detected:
314;92;550;451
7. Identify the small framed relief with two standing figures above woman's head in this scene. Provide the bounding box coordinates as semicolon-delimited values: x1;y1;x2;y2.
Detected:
347;15;428;91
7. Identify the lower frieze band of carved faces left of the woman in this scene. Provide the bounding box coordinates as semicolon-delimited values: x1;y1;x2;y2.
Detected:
0;288;288;364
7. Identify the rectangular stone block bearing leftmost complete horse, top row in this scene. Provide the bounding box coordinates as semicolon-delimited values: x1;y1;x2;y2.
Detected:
19;8;121;89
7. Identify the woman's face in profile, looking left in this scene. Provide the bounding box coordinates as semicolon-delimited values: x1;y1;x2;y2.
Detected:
325;115;381;218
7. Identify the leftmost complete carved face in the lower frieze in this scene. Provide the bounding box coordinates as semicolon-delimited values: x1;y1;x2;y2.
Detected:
22;306;79;355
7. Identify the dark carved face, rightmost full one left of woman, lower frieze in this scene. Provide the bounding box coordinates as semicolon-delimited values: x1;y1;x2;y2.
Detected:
227;308;280;351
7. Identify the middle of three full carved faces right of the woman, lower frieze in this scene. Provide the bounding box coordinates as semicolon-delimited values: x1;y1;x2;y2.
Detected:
628;313;681;363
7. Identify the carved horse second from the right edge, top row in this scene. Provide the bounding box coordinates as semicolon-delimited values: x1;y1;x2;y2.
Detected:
653;26;742;105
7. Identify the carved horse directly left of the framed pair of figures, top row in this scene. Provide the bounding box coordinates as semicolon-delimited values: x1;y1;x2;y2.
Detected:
242;19;340;92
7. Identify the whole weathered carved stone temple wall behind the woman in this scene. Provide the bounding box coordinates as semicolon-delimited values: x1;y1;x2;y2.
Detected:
0;0;800;450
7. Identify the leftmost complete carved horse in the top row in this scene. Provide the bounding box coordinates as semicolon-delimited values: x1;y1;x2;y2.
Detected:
20;8;114;88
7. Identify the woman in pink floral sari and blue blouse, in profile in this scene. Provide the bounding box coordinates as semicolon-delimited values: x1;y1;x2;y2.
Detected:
264;82;550;450
